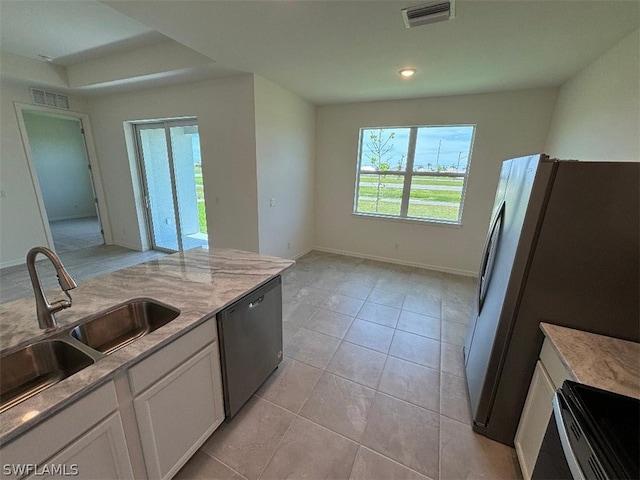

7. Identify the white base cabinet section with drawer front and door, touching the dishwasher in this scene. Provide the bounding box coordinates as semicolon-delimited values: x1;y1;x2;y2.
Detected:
130;319;224;479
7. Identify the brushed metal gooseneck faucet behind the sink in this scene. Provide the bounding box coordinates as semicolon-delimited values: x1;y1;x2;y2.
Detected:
27;247;78;330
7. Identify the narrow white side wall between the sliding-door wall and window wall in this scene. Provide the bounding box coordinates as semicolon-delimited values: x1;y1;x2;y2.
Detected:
254;75;315;258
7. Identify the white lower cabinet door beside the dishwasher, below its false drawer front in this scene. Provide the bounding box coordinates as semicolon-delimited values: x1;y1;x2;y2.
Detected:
133;342;224;479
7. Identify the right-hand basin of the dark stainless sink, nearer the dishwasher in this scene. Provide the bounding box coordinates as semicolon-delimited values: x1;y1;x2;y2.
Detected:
71;298;180;355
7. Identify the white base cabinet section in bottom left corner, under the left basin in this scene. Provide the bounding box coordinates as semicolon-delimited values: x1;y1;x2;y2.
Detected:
0;382;133;479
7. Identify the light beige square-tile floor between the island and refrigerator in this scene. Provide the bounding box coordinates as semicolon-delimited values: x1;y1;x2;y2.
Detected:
176;252;521;480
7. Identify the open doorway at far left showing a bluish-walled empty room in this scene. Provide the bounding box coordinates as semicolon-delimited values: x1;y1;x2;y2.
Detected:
22;110;105;254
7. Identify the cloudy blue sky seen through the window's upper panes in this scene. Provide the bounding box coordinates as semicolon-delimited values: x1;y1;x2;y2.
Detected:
362;125;474;171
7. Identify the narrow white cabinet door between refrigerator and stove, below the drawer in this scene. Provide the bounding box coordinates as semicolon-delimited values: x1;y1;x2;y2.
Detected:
515;361;555;480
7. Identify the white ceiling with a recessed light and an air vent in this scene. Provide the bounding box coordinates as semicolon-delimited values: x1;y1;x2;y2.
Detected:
0;0;640;104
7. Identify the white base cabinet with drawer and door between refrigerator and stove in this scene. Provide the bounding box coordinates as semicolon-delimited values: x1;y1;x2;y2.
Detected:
515;339;574;480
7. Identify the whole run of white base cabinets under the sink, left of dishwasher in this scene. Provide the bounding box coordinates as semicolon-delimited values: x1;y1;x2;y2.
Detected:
0;318;224;480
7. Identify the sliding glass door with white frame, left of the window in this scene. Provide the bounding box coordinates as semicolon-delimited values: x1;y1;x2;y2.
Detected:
134;119;208;252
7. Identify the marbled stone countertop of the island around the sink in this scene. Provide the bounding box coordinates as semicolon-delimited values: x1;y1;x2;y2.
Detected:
0;248;294;445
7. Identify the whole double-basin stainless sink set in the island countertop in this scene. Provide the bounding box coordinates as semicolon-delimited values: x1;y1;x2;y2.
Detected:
0;298;180;413
